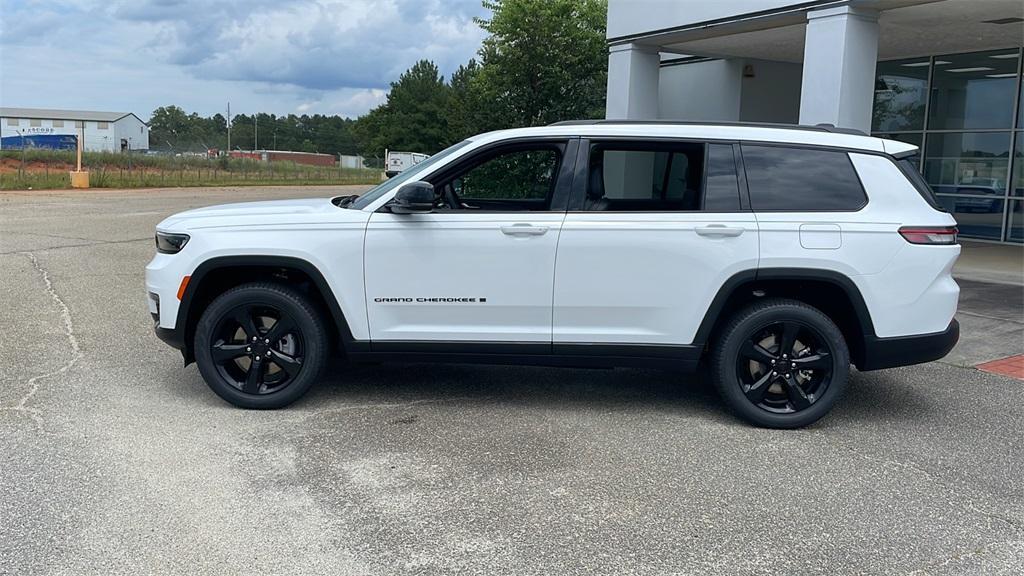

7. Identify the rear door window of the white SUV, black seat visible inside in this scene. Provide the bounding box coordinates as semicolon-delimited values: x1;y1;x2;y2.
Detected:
584;142;739;212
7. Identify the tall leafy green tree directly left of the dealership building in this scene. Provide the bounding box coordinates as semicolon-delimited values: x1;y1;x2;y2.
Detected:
473;0;608;129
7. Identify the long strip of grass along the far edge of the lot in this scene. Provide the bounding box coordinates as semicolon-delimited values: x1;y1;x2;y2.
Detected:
0;150;381;190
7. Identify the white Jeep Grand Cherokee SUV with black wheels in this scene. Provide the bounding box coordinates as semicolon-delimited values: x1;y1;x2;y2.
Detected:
146;121;959;427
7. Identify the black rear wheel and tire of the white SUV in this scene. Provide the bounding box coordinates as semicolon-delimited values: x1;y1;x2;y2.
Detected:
712;298;850;428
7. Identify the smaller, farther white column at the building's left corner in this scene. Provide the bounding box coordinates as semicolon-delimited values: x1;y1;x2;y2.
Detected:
605;44;660;120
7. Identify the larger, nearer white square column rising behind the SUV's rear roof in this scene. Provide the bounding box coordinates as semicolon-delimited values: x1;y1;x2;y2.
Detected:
800;6;879;132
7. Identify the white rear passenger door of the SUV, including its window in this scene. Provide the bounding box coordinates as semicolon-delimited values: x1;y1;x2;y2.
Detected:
553;139;758;344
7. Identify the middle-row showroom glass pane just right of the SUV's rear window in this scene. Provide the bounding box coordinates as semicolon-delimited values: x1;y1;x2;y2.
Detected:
925;132;1010;196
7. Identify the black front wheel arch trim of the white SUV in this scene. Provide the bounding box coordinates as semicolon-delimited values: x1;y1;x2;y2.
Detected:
175;255;354;364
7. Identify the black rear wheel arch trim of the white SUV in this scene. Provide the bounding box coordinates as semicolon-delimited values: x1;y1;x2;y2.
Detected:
693;268;874;367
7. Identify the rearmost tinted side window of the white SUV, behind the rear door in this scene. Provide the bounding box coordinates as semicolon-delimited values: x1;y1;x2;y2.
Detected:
742;145;867;212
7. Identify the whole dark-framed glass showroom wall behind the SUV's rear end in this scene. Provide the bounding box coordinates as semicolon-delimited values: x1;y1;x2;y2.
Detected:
871;48;1024;242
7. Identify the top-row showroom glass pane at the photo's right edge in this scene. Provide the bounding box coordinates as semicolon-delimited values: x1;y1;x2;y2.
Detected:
928;48;1020;130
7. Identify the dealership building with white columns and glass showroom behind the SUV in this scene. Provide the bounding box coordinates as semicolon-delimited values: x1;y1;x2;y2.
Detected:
607;0;1024;243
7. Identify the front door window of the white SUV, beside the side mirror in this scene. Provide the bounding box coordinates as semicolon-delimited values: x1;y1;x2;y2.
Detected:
440;147;561;211
